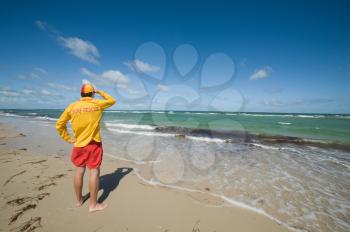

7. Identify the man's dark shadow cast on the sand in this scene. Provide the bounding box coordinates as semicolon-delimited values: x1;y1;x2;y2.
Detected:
83;168;133;203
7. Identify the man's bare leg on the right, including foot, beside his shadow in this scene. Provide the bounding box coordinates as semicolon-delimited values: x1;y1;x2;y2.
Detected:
89;168;107;212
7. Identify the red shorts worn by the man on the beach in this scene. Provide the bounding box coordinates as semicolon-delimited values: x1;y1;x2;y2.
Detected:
70;141;103;169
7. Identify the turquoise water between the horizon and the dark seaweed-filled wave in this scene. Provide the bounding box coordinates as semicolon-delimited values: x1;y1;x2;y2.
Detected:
0;109;350;144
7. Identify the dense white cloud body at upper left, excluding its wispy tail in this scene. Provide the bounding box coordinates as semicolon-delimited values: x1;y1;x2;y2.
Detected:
59;36;100;64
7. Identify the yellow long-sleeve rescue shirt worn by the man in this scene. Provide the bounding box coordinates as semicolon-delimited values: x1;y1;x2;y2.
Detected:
56;91;116;147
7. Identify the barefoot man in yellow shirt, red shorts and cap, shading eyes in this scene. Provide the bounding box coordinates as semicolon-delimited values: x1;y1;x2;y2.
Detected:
56;84;116;212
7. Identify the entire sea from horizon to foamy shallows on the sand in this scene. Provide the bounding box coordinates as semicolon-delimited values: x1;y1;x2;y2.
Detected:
0;109;350;232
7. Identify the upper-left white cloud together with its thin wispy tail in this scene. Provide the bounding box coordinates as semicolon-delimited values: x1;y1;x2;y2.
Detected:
35;21;100;64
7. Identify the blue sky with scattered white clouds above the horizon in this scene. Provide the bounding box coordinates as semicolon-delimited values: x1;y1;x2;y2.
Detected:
0;0;350;113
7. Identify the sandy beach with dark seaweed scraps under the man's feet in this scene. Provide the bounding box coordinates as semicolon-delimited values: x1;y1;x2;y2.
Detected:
0;118;288;232
